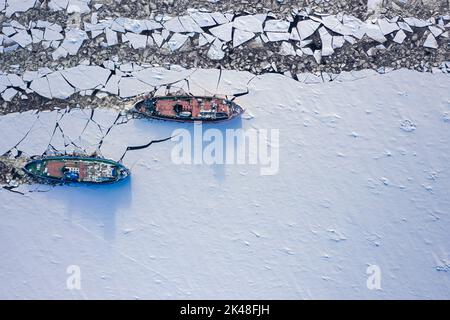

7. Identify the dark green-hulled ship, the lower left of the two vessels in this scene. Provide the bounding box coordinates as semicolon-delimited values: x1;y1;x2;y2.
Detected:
23;156;130;185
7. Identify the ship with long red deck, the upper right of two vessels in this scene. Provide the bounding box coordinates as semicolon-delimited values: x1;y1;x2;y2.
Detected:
134;96;244;123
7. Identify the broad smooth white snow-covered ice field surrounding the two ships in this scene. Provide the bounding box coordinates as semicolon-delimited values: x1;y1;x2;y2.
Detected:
0;70;450;299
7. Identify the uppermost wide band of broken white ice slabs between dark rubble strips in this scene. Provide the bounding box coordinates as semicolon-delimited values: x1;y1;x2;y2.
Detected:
0;10;450;60
